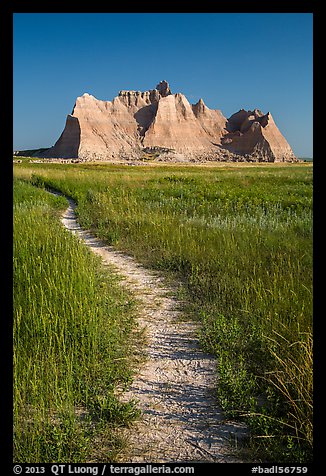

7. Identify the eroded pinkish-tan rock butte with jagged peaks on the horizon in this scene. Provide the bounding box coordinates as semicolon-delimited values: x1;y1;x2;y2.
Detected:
42;81;297;162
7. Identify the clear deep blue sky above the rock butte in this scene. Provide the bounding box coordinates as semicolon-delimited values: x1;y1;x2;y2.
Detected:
13;13;313;157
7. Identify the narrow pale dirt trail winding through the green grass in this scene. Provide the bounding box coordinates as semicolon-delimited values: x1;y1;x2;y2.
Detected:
56;192;246;463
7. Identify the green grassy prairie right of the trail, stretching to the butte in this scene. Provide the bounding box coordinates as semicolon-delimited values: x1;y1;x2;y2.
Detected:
15;164;312;462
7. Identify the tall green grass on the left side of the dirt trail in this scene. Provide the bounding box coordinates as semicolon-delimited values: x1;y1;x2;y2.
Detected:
13;181;139;462
